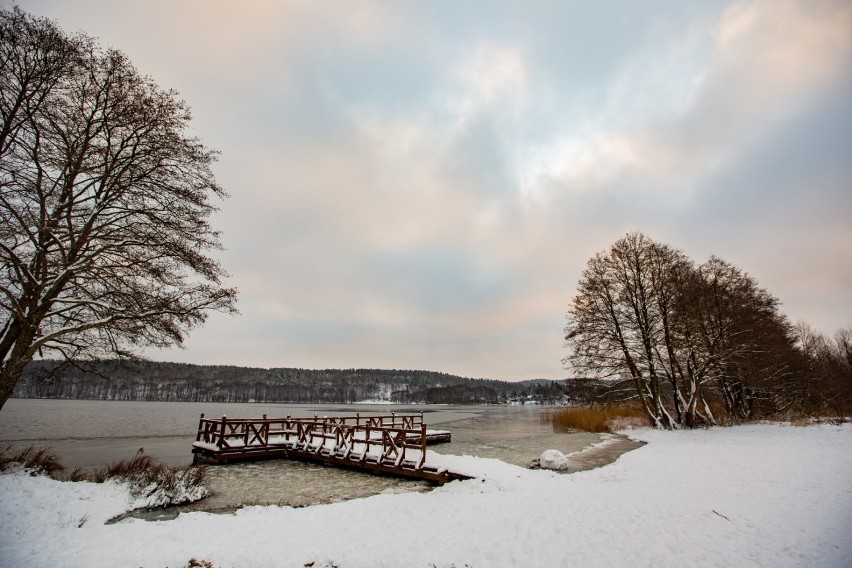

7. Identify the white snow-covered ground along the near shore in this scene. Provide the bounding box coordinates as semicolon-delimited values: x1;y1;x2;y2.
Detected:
0;424;852;568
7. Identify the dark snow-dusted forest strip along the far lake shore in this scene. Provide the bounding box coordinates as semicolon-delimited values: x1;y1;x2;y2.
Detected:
14;360;597;404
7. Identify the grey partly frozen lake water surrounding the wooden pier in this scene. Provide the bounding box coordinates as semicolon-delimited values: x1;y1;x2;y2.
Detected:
0;399;601;510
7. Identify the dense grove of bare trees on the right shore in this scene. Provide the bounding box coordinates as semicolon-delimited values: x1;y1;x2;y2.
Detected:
564;233;852;428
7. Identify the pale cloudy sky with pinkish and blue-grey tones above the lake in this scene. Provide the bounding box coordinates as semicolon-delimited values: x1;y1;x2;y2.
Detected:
8;0;852;380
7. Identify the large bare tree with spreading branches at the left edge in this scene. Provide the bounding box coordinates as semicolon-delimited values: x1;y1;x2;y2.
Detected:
0;8;236;408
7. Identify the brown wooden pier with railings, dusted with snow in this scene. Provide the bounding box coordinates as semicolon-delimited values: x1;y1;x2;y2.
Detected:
192;413;469;484
